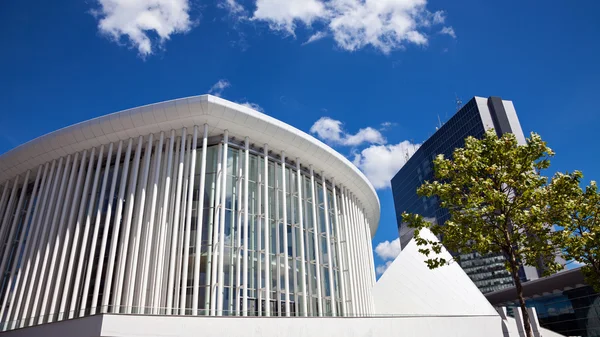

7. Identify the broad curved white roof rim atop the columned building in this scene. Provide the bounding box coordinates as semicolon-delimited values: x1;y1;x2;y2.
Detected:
0;95;380;235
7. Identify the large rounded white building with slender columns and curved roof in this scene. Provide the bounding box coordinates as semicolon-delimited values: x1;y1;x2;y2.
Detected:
0;96;379;330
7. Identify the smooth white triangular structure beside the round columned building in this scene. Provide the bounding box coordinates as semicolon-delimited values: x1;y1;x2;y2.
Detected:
373;229;498;316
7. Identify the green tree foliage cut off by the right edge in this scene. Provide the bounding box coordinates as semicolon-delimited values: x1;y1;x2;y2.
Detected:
550;171;600;291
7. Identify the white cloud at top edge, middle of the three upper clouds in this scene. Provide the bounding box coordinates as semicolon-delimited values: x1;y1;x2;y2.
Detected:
252;0;327;35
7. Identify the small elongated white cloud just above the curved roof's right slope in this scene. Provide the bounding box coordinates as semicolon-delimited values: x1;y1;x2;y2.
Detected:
310;117;386;146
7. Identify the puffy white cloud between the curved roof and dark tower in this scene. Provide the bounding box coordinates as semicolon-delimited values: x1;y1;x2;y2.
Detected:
353;140;420;189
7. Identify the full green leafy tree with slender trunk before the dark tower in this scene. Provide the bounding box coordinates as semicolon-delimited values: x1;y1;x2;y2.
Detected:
402;130;561;337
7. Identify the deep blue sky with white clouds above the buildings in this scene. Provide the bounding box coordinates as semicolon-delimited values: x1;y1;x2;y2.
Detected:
0;0;600;274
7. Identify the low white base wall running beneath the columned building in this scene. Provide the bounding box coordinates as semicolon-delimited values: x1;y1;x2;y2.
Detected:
0;314;503;337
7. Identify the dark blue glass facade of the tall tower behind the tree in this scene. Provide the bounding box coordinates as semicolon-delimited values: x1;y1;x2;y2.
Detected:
392;98;524;293
